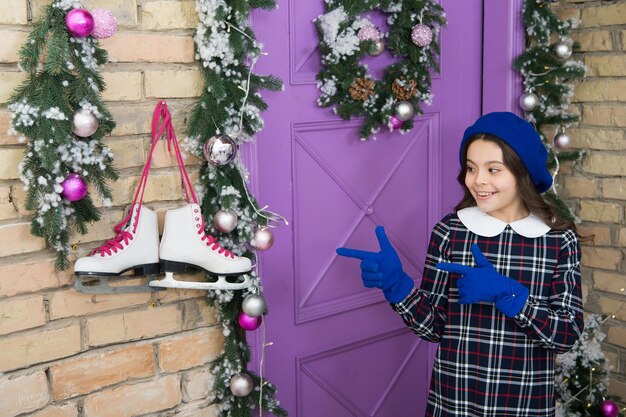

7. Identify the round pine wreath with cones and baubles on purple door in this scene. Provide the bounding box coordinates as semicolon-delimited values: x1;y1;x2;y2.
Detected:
315;0;447;140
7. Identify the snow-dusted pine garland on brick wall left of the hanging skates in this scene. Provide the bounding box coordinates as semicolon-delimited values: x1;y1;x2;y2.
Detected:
9;0;118;270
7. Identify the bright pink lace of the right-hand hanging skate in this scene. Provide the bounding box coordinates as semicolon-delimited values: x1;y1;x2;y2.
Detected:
153;100;235;259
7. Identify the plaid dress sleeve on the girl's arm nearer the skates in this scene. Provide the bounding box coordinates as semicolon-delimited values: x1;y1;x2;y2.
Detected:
392;219;450;342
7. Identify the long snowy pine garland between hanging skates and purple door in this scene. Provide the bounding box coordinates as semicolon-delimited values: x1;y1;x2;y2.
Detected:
185;0;287;417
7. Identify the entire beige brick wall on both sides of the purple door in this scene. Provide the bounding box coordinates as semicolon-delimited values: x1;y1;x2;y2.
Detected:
0;0;626;417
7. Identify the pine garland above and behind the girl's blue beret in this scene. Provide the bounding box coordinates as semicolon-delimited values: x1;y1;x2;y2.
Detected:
514;0;586;221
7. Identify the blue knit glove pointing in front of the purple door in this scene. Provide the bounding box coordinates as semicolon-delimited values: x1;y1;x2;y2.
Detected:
337;226;413;304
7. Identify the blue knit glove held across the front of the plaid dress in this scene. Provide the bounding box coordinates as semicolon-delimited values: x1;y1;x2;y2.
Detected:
437;243;528;317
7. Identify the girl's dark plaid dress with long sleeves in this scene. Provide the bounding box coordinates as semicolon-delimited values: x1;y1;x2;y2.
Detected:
392;208;583;417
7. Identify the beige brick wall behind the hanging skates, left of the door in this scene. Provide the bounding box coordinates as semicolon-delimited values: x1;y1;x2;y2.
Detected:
0;0;223;417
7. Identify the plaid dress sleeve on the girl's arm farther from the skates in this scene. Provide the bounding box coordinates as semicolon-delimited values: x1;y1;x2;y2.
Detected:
515;231;584;354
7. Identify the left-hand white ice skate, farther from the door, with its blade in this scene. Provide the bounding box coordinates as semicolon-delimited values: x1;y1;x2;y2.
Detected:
74;204;163;294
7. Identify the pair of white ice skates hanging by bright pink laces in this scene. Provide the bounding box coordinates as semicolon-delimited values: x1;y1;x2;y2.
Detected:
74;101;252;294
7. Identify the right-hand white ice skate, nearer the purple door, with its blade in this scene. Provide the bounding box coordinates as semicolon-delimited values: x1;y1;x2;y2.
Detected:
150;203;252;290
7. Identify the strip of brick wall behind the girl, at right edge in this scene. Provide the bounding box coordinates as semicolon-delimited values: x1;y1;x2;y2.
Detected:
559;0;626;400
